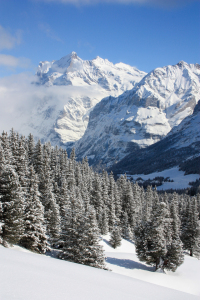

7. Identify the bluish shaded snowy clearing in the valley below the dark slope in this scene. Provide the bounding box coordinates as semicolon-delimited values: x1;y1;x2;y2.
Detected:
127;167;200;190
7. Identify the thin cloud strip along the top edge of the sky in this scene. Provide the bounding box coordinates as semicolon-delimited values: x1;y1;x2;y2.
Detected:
34;0;197;7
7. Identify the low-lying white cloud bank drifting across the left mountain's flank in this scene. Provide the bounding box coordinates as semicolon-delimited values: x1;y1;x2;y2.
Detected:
0;72;105;139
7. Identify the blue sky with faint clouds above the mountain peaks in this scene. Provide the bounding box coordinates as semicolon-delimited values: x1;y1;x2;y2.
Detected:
0;0;200;77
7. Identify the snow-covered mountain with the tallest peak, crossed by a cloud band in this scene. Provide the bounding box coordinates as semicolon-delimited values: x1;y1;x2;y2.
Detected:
31;52;146;143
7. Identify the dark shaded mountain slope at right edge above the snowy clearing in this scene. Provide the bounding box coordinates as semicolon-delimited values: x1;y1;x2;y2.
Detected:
109;100;200;175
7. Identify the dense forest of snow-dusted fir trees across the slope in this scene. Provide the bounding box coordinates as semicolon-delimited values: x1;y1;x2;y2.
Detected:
0;130;200;271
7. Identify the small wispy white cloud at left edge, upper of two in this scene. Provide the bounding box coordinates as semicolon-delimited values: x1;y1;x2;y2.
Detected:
0;25;22;50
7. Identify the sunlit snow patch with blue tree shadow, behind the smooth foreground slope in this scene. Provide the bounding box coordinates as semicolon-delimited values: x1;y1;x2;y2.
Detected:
102;235;200;300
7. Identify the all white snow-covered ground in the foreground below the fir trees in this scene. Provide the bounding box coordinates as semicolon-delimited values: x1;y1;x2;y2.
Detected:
0;236;200;300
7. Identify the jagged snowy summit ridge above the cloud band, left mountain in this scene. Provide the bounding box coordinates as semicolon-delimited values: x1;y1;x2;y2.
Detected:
37;52;146;91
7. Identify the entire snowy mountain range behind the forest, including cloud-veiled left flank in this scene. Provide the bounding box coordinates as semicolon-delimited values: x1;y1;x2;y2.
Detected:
0;52;200;173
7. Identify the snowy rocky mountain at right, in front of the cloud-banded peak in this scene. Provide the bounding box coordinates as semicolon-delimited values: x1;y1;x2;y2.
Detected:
75;61;200;166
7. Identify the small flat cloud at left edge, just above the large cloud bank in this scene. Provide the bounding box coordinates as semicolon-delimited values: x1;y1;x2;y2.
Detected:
0;54;31;68
